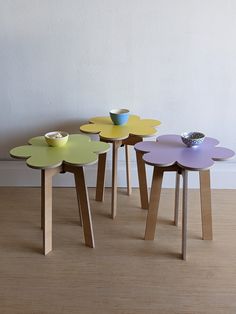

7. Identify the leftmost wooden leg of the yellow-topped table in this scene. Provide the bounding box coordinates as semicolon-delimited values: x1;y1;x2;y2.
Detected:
96;153;107;202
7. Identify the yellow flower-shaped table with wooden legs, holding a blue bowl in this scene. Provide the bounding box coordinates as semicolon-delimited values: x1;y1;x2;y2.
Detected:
80;115;160;218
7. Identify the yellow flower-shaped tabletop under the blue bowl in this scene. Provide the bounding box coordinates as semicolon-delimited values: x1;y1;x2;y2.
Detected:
80;115;161;140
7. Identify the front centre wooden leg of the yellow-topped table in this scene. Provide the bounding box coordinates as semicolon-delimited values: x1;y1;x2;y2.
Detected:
111;141;122;219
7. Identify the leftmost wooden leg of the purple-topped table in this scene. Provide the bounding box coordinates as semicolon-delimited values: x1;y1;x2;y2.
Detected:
145;167;163;240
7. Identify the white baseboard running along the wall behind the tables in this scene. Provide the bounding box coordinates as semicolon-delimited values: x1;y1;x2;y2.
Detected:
0;160;236;189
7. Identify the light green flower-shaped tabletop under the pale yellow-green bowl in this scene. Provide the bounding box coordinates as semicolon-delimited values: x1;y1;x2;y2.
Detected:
10;134;110;169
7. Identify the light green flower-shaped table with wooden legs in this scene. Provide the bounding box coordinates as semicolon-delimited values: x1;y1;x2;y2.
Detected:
10;134;109;255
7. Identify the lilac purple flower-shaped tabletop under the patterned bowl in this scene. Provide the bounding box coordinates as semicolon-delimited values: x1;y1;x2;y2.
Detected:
134;135;235;170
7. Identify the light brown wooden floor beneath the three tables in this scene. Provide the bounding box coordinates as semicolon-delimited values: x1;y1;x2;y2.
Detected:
0;188;236;314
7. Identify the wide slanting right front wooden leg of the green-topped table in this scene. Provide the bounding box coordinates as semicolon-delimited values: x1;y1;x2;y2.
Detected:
74;167;95;248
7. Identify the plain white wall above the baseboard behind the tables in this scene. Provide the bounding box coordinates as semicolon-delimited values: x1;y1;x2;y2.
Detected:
0;0;236;183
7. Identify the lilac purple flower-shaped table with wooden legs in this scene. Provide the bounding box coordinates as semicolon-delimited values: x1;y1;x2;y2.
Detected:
135;135;234;259
